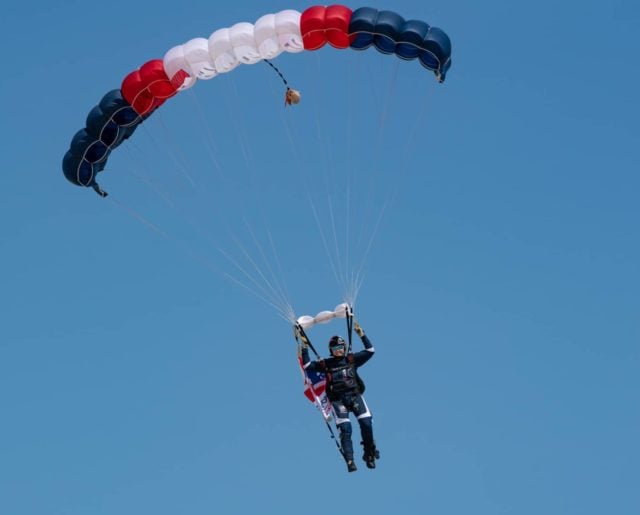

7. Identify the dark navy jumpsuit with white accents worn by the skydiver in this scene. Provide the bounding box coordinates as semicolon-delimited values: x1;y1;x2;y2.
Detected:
302;334;375;461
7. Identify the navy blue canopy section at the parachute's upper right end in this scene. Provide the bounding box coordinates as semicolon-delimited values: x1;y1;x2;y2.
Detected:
349;7;451;82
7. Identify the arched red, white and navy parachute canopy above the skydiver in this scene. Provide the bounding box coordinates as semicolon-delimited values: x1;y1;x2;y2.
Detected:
62;5;451;196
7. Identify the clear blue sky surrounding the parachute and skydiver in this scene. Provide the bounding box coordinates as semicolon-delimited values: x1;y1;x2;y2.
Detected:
0;0;640;515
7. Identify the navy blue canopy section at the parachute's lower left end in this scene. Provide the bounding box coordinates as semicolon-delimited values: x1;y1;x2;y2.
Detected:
62;89;144;194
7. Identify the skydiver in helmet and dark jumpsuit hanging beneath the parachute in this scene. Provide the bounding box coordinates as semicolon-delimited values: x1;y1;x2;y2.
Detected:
302;322;380;472
